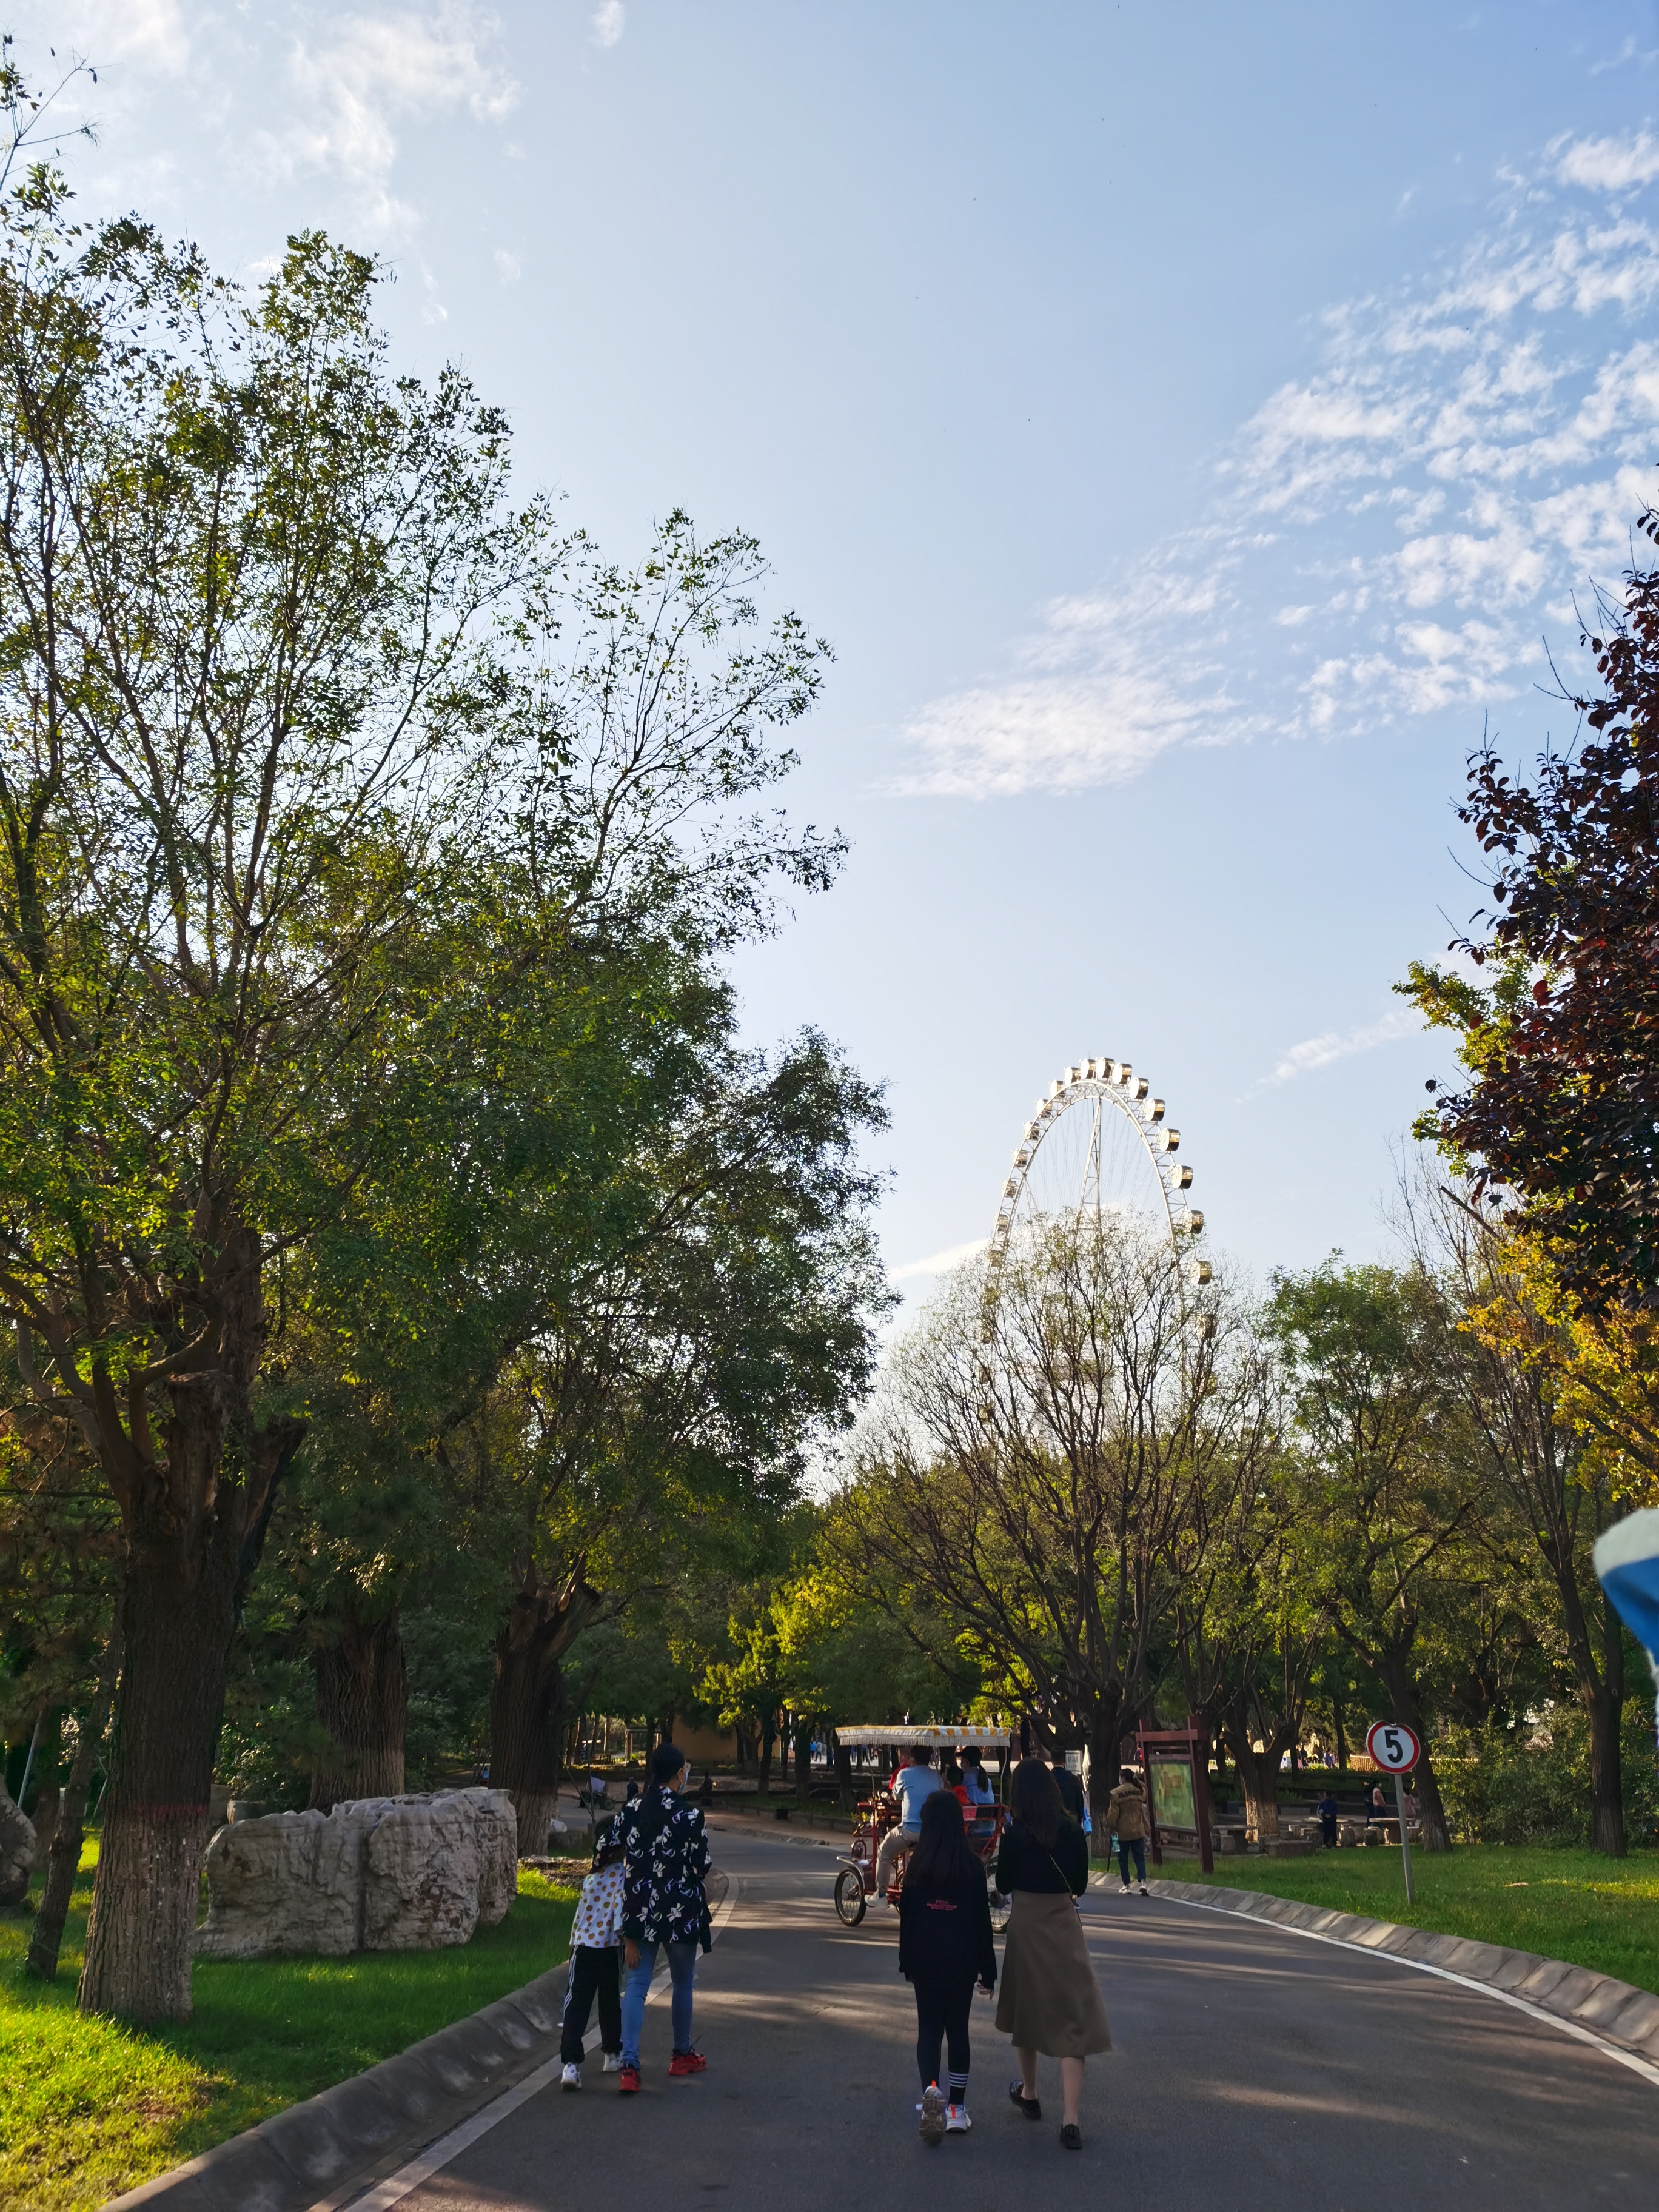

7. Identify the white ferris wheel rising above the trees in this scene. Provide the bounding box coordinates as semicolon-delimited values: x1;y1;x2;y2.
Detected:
984;1059;1210;1323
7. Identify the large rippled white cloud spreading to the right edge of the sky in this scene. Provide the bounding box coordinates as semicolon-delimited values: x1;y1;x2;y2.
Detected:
891;133;1659;799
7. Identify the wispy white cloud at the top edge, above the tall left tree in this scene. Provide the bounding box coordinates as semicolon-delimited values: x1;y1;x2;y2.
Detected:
261;4;518;239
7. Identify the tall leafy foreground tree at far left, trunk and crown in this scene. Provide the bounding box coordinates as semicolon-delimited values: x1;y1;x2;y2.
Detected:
0;199;559;2017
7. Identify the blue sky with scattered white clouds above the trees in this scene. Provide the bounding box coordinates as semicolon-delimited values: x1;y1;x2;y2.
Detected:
29;0;1659;1301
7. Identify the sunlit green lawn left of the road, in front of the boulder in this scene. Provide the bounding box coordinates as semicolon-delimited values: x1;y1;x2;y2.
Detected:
0;1843;575;2212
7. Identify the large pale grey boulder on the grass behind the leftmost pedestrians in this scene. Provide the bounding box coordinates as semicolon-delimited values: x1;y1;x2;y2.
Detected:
197;1789;518;1957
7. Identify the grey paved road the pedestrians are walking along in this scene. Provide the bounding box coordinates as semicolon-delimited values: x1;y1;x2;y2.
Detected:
383;1829;1659;2212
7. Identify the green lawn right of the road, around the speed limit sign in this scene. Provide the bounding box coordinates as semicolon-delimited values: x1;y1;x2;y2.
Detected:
1164;1843;1659;1991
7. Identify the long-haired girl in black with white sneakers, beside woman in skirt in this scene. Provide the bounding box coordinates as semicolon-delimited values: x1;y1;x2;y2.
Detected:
898;1789;997;2143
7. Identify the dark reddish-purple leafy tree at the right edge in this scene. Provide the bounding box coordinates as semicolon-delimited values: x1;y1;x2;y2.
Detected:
1404;493;1659;1310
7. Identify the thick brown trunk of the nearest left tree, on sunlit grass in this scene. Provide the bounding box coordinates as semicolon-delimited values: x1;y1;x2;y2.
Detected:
78;1500;239;2022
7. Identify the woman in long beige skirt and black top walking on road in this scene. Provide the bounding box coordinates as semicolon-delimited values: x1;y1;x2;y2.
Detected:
997;1758;1113;2150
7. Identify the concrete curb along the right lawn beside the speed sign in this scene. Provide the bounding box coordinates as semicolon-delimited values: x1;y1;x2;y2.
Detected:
1150;1876;1659;2064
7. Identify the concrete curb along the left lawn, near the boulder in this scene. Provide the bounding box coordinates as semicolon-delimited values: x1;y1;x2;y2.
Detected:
102;1869;730;2212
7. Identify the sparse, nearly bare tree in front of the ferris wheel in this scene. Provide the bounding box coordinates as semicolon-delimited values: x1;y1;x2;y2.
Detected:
834;1216;1276;1809
